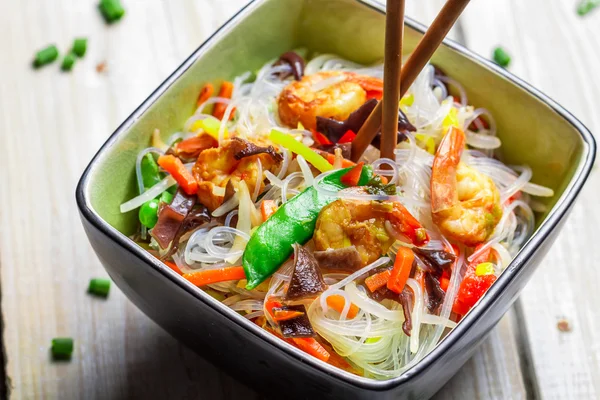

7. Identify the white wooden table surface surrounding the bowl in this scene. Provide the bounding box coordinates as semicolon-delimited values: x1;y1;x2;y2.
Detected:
0;0;600;399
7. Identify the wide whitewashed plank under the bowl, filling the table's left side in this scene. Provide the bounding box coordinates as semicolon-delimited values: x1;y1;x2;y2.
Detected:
0;0;523;399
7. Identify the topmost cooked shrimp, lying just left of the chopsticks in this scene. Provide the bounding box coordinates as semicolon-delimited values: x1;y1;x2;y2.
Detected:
278;71;383;129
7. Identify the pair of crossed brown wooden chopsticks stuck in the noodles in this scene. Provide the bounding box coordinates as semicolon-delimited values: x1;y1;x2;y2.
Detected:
352;0;469;162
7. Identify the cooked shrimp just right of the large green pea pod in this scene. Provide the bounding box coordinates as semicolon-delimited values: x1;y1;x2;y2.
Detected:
313;200;429;265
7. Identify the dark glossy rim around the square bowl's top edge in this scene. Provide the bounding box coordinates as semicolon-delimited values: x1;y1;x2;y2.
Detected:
75;0;596;391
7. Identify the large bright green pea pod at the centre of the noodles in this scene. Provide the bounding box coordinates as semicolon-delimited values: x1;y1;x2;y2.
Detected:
242;167;373;290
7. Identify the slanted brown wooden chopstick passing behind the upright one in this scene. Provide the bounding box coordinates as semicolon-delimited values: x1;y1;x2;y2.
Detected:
351;0;469;162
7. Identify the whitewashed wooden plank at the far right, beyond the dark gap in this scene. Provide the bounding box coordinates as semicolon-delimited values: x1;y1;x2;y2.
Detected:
463;0;600;399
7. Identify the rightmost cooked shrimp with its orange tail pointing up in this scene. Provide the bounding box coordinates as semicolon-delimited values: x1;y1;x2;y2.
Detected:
431;127;502;246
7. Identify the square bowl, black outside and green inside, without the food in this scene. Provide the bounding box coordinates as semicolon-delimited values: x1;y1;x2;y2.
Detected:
76;0;595;399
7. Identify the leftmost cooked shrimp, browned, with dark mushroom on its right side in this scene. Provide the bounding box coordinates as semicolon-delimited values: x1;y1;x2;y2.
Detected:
192;137;282;212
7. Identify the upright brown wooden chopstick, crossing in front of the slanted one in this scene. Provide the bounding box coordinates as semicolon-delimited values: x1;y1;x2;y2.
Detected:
381;0;405;160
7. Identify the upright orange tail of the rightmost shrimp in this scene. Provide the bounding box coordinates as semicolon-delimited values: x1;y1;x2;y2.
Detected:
431;127;466;214
